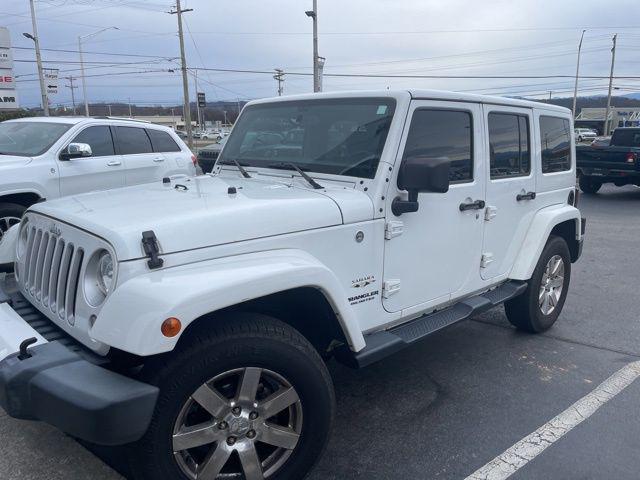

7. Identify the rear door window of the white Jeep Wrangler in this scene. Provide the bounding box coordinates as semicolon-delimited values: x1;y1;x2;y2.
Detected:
488;113;531;179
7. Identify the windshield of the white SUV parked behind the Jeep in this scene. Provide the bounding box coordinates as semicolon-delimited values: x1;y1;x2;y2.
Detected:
0;122;71;157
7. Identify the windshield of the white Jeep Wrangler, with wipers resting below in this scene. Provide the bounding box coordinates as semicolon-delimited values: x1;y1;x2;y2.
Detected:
218;98;395;178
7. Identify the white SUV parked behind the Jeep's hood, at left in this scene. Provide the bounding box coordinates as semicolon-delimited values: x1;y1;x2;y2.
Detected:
0;117;196;241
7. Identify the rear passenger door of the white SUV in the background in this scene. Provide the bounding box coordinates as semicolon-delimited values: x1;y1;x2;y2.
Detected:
113;126;165;185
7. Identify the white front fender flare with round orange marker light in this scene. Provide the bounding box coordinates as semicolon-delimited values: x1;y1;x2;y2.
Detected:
90;249;365;356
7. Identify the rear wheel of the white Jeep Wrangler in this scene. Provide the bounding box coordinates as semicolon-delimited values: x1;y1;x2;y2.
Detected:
505;236;571;333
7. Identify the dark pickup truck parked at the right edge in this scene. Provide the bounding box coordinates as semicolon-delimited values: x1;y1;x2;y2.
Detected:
576;128;640;193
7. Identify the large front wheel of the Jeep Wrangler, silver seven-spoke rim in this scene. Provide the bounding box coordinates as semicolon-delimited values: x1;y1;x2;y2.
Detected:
128;314;335;480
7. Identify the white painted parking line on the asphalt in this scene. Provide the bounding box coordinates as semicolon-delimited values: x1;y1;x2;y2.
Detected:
465;361;640;480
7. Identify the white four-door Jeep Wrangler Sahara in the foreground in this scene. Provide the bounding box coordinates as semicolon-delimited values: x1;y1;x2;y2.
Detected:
0;91;585;480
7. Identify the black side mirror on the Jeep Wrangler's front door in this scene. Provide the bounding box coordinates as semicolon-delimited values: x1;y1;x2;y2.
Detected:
391;156;451;216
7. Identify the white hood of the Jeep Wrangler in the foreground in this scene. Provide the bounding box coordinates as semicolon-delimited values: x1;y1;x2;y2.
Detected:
31;176;373;261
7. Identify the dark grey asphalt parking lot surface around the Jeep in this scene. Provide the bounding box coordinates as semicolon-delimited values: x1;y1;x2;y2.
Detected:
0;186;640;480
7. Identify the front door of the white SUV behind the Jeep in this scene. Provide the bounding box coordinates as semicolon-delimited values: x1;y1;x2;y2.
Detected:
58;125;125;196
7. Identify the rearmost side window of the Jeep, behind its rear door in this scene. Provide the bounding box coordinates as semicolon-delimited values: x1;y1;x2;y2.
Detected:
540;116;571;173
